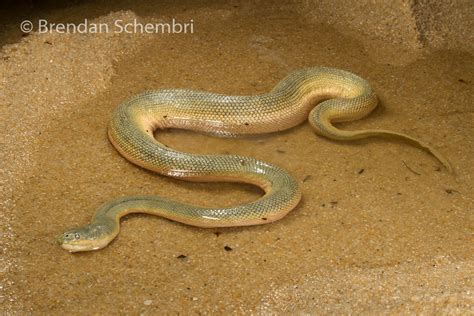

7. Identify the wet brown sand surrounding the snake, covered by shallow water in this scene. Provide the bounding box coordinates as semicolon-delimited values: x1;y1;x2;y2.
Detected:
0;1;474;314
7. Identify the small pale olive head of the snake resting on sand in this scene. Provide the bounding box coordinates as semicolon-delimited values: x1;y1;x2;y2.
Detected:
58;225;115;252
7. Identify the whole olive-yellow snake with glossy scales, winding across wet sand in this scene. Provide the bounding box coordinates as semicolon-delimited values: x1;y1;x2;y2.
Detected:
58;67;451;252
